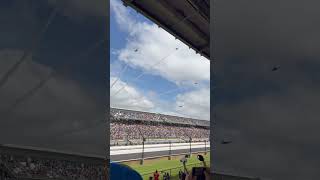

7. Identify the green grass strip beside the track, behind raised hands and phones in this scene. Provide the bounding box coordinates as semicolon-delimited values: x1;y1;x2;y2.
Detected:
123;153;210;179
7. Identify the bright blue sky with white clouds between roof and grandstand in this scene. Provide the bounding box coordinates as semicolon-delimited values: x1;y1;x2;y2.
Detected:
110;0;210;120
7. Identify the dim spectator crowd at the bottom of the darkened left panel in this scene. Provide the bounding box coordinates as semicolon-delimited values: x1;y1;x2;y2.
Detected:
0;154;103;180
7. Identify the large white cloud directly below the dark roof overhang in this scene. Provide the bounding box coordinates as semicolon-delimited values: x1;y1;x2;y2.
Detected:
111;0;210;84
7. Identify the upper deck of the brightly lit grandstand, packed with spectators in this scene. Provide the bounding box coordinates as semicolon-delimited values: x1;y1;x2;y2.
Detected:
110;108;210;127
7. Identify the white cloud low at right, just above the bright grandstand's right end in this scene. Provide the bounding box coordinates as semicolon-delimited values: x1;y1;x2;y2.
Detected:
175;88;210;120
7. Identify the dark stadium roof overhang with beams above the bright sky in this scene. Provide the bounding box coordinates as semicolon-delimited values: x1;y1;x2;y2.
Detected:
122;0;210;59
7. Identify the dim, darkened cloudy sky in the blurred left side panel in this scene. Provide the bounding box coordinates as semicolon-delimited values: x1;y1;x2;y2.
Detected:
0;0;108;156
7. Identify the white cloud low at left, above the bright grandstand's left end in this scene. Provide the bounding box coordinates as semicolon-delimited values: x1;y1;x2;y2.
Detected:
110;77;154;111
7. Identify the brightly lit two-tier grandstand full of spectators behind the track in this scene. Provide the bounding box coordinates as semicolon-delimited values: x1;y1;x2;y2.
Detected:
110;108;210;145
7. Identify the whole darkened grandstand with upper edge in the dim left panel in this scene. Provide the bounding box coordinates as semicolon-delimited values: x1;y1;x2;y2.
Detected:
0;145;105;180
